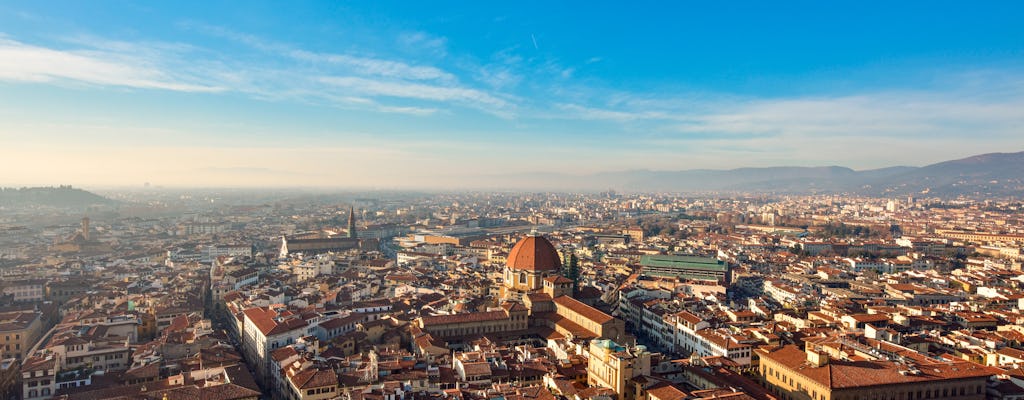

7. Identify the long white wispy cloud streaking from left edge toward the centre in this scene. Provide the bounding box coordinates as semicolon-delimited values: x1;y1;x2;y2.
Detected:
0;24;515;118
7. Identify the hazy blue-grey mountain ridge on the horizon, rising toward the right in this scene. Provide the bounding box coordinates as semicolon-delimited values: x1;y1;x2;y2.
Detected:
487;151;1024;196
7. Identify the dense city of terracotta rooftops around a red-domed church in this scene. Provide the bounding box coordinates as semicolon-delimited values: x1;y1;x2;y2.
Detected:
0;189;1024;400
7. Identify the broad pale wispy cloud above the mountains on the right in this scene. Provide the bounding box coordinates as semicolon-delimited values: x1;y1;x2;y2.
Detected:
561;75;1024;141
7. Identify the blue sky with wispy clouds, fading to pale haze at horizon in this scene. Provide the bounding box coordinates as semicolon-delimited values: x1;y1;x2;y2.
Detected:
0;0;1024;188
